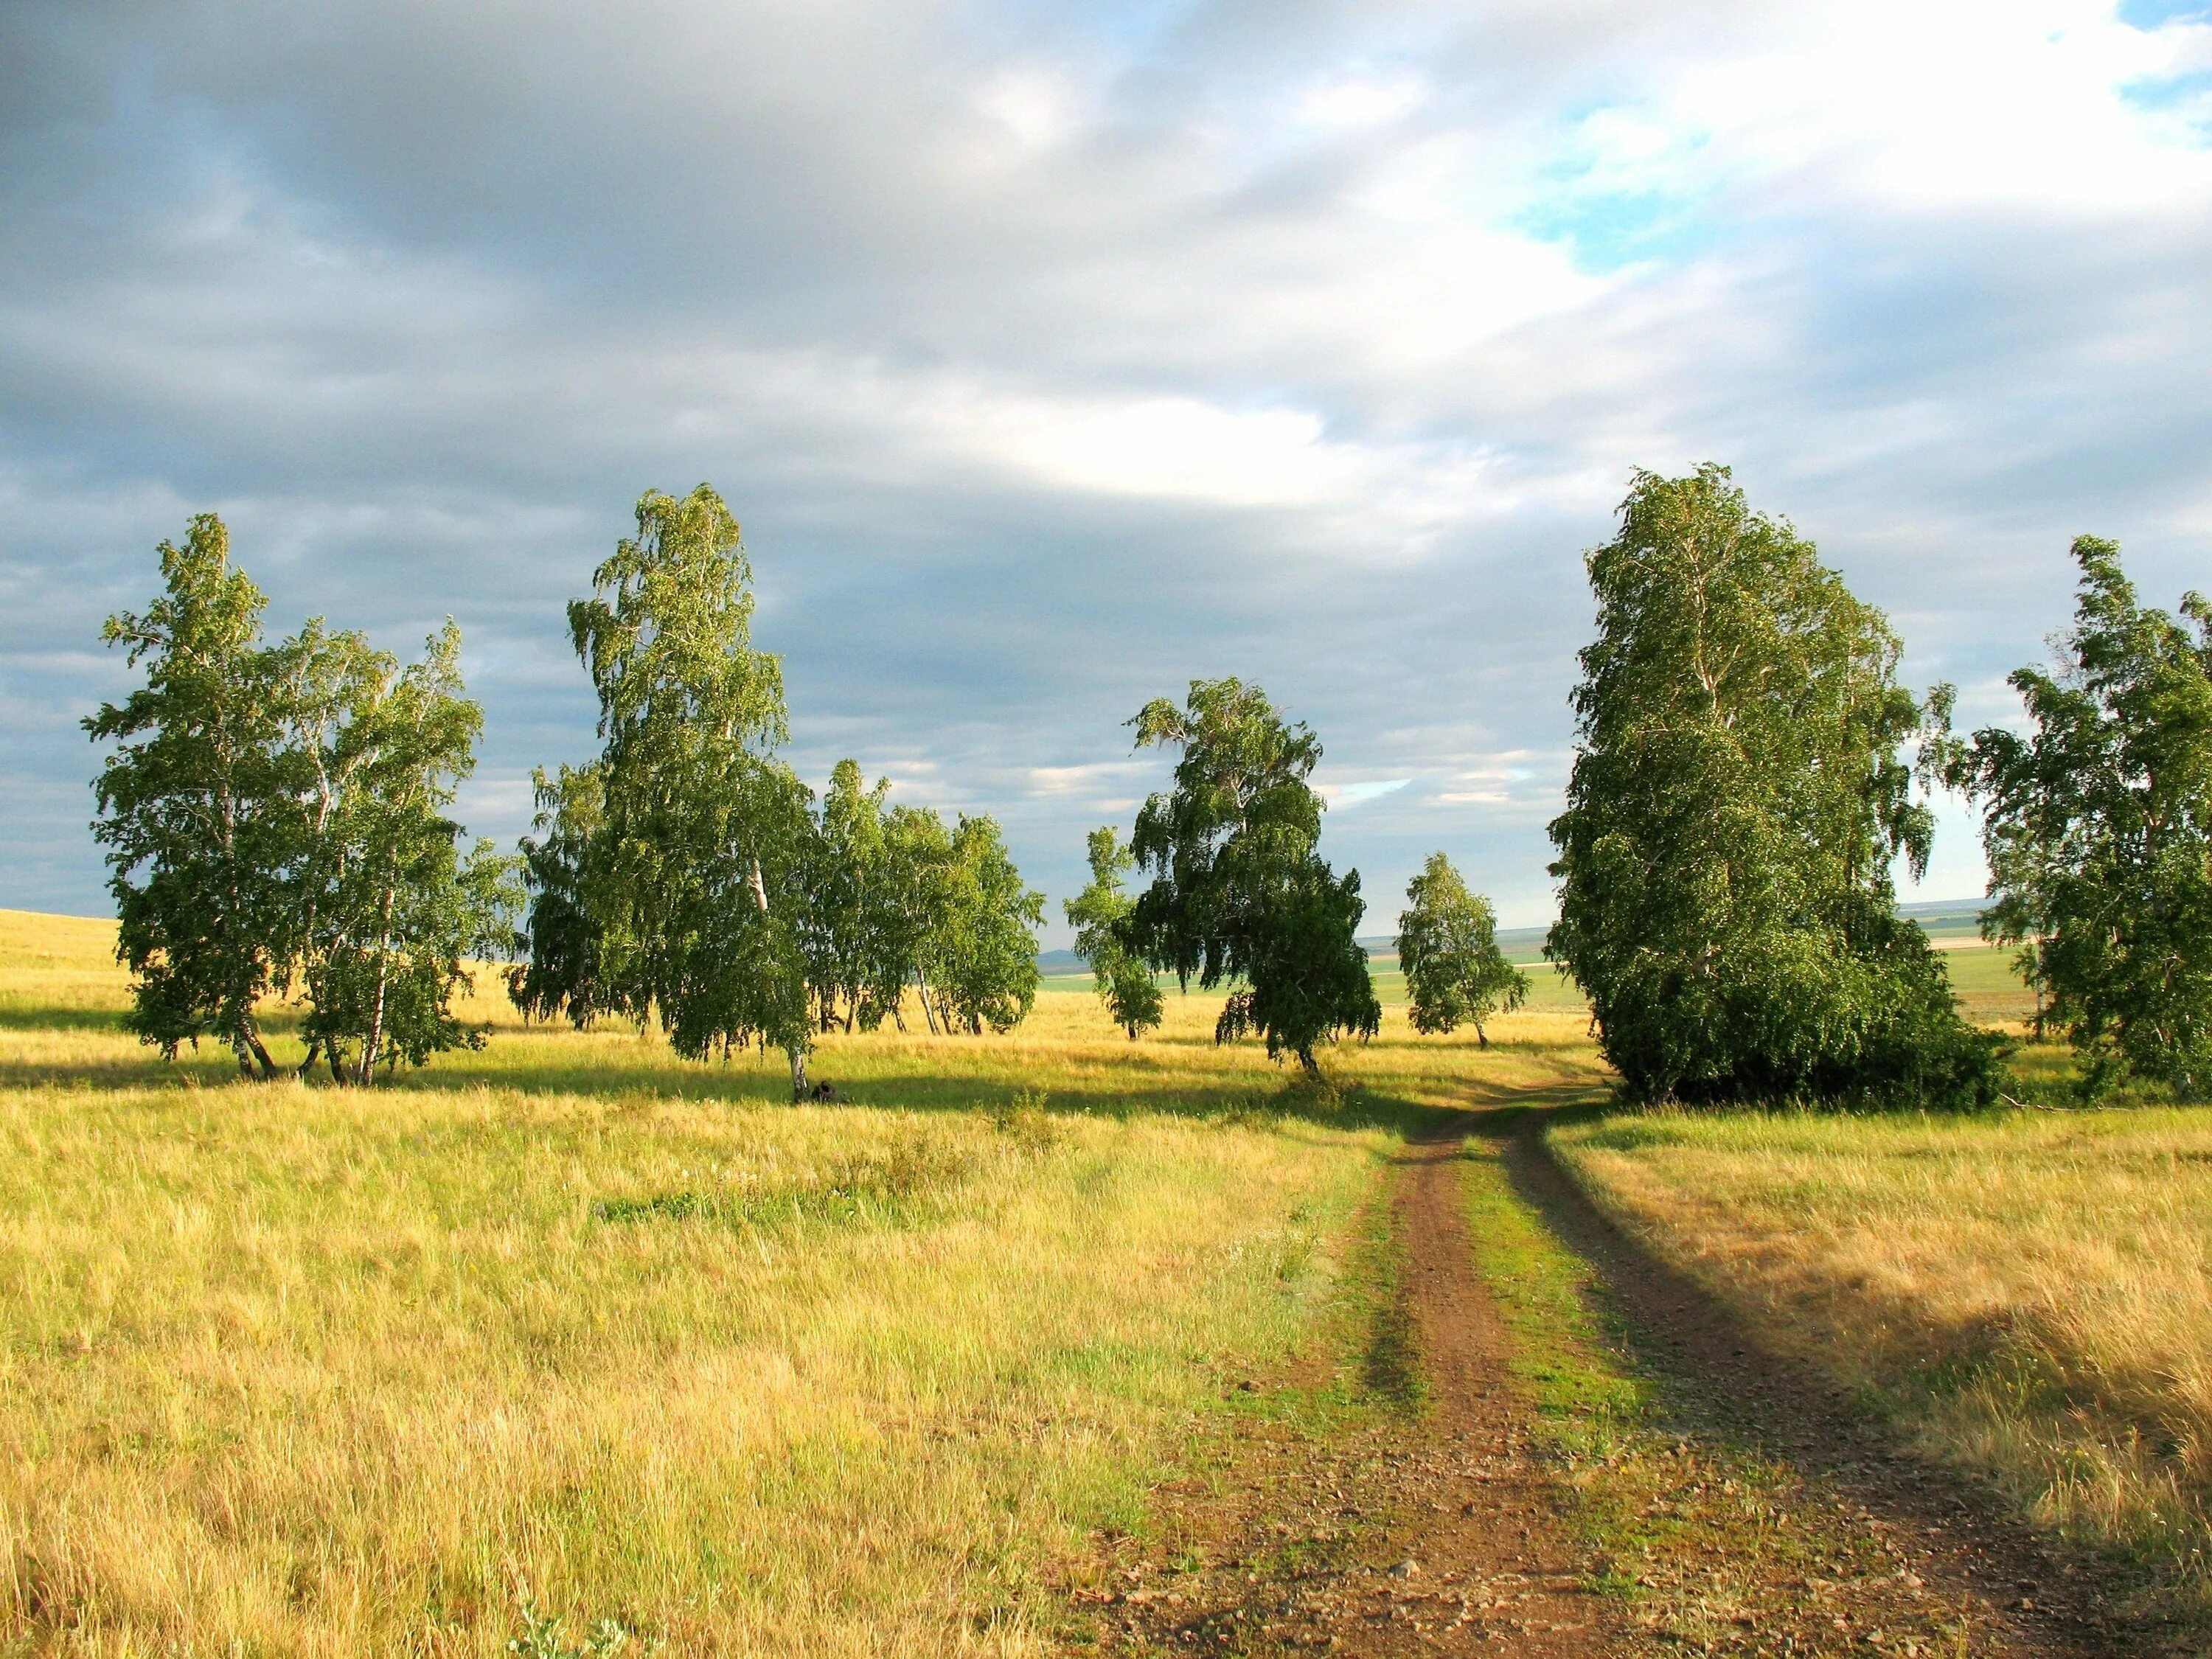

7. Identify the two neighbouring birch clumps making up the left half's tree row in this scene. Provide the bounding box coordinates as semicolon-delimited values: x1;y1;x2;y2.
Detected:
86;484;1044;1095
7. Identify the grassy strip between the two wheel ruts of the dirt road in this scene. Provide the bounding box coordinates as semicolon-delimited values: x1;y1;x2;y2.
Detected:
1462;1124;1978;1657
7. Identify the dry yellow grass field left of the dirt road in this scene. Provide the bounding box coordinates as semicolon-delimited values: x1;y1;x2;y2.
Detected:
0;914;1593;1657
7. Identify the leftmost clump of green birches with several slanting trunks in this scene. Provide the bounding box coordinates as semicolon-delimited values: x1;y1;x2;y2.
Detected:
86;515;520;1084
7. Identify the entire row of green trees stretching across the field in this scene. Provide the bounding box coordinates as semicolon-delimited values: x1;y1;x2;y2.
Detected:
86;467;2212;1102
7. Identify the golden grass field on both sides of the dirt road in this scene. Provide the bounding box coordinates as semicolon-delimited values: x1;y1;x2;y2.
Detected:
0;911;2212;1655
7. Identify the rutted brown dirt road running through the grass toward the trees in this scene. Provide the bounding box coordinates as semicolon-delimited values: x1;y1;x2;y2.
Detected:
1075;1113;2163;1659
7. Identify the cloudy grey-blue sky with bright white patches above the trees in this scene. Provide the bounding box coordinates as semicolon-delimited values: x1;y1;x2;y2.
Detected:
0;0;2212;945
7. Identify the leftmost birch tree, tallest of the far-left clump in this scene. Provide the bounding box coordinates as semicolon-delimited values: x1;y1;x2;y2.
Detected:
84;513;301;1093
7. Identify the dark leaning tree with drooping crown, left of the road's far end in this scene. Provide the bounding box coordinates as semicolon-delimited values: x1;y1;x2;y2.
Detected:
1121;679;1382;1077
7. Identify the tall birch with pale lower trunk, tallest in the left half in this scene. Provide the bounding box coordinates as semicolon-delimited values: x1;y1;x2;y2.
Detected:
557;484;814;1099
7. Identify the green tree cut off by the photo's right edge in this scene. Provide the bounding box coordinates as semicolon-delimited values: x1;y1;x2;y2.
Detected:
1924;535;2212;1099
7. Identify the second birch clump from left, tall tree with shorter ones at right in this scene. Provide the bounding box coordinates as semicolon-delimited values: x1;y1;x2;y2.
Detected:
513;484;1044;1097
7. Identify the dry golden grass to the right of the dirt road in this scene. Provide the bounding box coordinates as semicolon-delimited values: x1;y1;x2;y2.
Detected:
1553;1106;2212;1626
